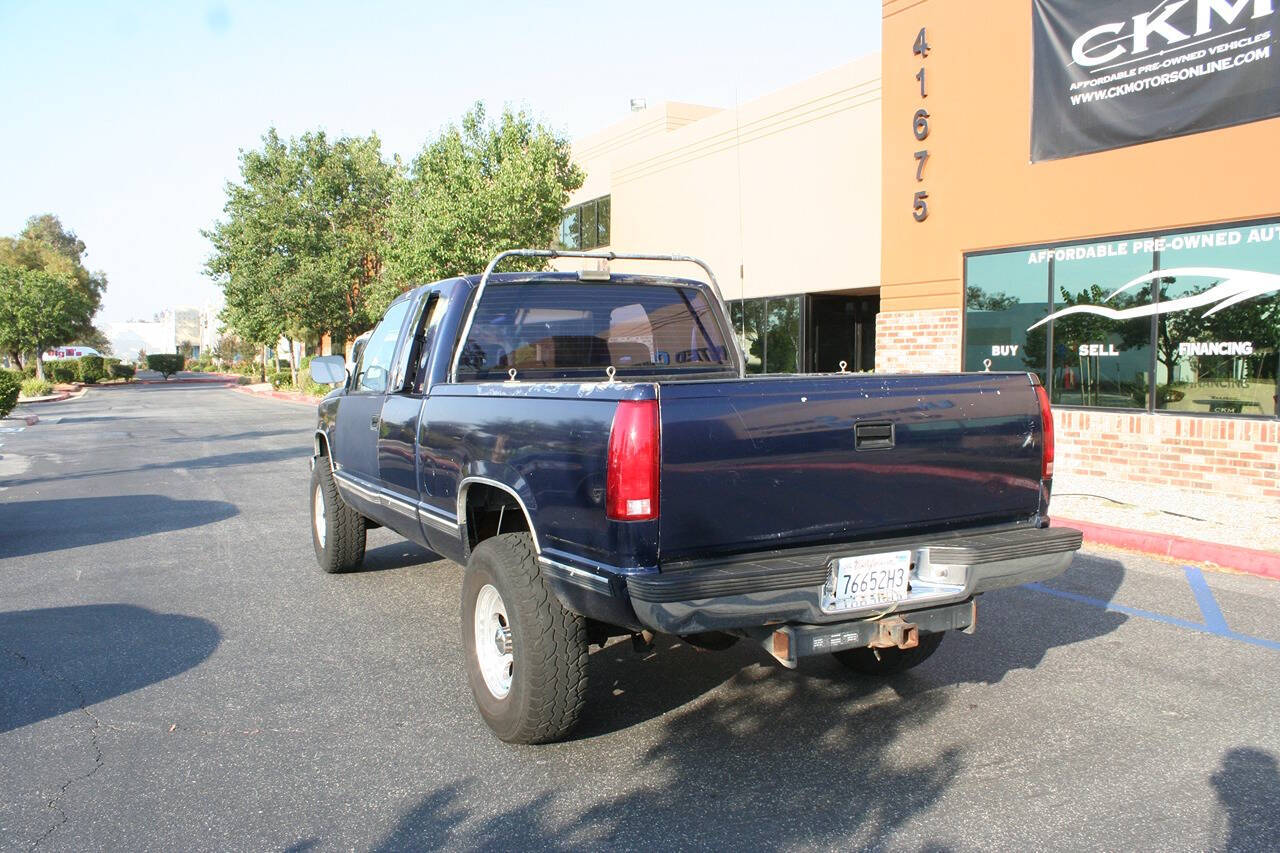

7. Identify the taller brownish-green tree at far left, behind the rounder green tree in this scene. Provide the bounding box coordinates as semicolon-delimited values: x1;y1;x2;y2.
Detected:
0;214;106;369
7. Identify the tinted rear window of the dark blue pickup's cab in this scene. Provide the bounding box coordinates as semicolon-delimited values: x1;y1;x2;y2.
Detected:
458;280;737;382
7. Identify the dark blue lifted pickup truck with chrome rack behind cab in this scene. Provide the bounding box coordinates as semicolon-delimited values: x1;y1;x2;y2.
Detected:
311;250;1080;743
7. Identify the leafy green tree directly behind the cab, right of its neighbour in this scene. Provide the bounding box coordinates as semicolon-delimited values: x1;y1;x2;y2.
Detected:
384;102;582;303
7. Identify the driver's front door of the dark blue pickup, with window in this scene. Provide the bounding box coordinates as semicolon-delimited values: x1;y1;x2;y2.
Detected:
333;298;411;521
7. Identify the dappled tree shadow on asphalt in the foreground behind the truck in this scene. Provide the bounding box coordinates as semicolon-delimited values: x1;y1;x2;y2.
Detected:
379;649;961;850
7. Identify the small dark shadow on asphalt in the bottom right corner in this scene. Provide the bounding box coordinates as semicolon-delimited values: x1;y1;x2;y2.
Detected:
1210;747;1280;853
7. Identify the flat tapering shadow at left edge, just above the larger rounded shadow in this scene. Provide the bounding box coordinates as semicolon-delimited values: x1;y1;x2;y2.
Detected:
0;494;239;558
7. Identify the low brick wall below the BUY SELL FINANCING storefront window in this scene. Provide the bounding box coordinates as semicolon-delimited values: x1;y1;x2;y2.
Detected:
1053;409;1280;501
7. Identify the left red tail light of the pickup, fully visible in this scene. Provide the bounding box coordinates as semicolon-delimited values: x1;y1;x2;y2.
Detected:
605;400;659;521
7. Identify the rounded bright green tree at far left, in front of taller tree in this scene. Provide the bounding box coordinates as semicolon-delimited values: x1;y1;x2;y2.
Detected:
0;263;97;379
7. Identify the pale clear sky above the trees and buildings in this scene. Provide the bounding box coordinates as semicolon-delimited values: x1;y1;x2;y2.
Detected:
0;0;881;320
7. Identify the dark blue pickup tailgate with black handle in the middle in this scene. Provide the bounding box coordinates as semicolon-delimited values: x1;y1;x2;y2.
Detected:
659;373;1041;562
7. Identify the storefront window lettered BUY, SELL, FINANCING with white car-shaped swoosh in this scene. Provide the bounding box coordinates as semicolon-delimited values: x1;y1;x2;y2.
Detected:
964;222;1280;418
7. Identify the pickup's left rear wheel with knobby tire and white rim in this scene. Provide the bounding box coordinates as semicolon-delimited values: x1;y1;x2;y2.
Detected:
462;533;588;744
